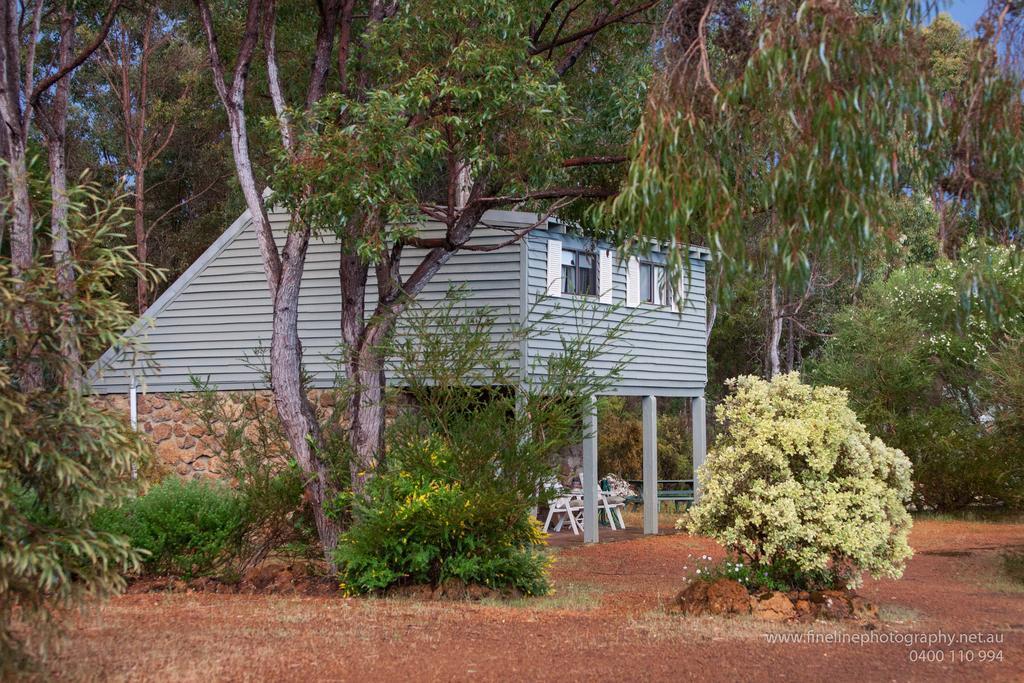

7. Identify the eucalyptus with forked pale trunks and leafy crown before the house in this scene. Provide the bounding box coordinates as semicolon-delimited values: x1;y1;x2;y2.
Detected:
192;0;657;559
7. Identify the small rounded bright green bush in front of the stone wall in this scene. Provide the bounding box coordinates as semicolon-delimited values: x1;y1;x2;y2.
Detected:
95;476;248;579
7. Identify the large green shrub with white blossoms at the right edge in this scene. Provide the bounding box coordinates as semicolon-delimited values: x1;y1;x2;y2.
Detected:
808;246;1024;510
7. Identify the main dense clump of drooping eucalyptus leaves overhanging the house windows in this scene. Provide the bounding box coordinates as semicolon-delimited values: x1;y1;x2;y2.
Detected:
608;0;937;287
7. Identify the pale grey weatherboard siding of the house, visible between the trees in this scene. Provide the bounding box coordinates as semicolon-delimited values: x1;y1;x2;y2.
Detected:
90;204;707;396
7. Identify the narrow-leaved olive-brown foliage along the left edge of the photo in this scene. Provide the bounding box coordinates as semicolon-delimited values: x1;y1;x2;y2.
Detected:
0;187;150;674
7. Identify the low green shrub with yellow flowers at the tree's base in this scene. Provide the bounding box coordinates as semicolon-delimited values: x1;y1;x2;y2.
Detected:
336;438;549;595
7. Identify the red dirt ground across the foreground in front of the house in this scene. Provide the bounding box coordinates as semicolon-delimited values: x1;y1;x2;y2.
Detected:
49;520;1024;682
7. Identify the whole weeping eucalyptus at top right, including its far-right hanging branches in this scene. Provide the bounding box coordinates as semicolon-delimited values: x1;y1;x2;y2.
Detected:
607;0;1024;362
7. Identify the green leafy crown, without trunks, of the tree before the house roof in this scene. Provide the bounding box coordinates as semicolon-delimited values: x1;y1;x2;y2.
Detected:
267;0;568;245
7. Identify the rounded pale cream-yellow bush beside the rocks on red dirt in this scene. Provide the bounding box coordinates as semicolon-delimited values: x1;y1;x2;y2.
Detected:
689;373;910;586
